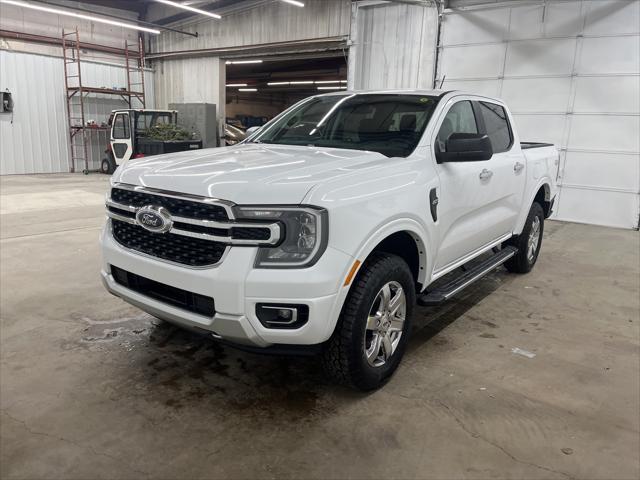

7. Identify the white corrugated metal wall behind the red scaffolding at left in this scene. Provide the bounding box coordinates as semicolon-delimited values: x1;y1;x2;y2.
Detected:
0;50;154;175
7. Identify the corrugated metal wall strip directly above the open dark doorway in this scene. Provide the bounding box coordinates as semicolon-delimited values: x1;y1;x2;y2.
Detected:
147;0;351;52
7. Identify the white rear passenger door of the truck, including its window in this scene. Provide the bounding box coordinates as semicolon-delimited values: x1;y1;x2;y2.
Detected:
474;100;527;239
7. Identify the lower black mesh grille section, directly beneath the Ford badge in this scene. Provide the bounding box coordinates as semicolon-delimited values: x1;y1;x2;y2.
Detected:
111;218;227;267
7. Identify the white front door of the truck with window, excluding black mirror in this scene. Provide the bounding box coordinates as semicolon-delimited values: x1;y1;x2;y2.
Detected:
432;97;499;275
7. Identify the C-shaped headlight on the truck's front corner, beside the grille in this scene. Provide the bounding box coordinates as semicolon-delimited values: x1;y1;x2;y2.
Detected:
234;207;329;268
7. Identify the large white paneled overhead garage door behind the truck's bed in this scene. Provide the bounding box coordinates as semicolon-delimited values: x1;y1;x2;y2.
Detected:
437;0;640;228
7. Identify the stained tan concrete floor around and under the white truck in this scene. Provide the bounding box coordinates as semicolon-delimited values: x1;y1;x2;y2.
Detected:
0;175;640;479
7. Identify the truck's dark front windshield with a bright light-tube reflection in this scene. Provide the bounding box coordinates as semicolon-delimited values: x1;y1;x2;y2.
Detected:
249;94;438;157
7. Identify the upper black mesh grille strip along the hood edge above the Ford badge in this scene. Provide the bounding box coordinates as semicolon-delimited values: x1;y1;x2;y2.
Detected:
111;187;229;222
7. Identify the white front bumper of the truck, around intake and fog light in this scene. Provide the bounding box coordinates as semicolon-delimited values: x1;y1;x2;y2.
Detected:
101;222;354;347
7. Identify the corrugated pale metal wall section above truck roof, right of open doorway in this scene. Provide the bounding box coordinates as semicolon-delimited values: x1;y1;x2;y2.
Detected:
348;3;438;90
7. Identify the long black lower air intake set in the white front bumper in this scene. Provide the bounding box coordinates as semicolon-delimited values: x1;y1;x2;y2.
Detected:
110;265;216;317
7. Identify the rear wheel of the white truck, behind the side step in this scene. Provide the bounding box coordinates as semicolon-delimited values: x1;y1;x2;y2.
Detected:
504;202;544;273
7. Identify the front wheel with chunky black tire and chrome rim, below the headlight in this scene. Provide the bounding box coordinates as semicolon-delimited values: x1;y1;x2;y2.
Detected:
322;253;416;390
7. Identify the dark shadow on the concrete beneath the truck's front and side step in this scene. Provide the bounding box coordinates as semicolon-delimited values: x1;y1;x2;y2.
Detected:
112;271;509;421
